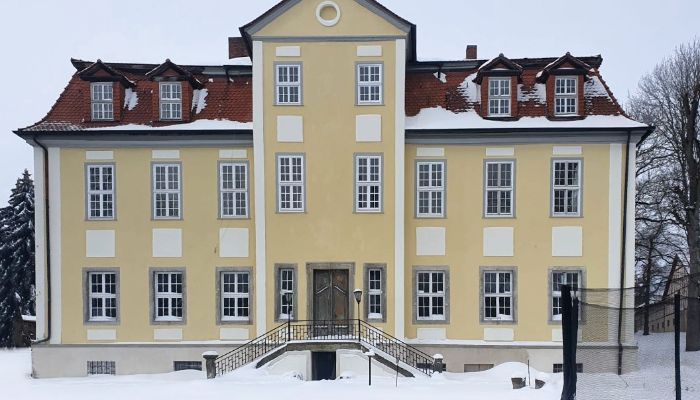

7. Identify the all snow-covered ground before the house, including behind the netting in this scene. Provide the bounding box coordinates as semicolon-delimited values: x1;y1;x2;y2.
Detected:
0;334;700;400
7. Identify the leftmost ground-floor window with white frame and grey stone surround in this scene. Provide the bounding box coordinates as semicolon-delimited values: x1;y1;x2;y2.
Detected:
87;272;117;322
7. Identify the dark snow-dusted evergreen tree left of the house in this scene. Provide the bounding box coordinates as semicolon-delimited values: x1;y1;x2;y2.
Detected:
0;170;35;347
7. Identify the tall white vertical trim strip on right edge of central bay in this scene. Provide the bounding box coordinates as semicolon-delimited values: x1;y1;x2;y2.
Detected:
394;39;406;340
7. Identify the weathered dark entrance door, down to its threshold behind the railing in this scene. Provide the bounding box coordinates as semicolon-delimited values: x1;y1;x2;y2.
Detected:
313;269;350;336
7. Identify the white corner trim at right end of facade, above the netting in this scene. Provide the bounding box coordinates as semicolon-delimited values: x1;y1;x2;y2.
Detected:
608;143;634;288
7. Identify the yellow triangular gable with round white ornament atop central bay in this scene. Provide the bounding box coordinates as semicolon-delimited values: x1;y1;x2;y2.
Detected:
241;0;414;39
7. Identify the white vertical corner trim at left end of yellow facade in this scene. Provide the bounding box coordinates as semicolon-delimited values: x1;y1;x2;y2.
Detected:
49;147;62;344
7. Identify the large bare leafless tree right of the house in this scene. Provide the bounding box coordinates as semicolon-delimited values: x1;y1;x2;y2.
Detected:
630;39;700;351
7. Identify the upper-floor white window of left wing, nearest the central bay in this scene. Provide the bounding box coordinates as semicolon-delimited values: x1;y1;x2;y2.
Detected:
219;163;248;218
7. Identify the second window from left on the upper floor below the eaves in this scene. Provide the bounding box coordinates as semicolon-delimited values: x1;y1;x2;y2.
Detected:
153;164;182;219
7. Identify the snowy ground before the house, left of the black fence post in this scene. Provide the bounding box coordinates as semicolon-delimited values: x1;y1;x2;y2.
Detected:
0;350;561;400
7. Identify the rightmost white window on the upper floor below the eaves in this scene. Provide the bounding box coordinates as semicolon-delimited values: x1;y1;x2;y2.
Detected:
552;160;581;217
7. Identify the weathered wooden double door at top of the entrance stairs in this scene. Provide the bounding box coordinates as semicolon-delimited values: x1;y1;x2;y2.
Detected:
313;264;351;324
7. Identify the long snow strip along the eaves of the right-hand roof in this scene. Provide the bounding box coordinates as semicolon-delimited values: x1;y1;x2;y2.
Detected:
406;107;646;129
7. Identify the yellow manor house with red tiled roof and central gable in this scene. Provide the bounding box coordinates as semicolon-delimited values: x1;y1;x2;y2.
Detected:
15;0;652;380
